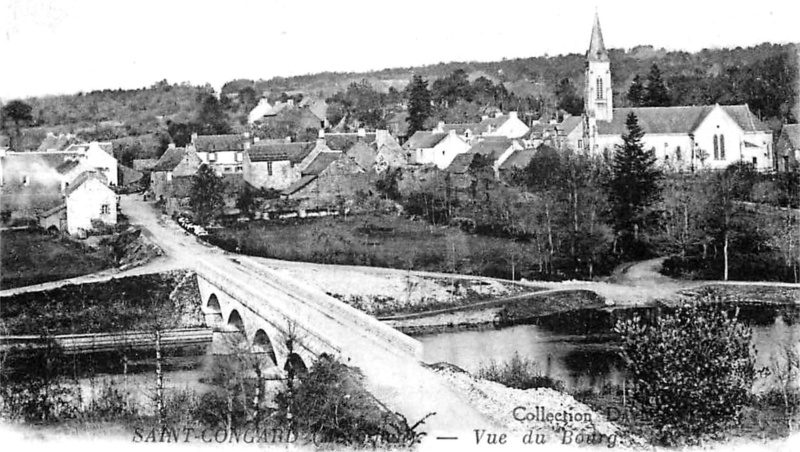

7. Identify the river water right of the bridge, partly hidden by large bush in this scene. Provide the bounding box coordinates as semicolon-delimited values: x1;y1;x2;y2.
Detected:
417;308;800;392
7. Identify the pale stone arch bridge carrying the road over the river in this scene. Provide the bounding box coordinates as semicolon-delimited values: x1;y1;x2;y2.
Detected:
195;256;422;376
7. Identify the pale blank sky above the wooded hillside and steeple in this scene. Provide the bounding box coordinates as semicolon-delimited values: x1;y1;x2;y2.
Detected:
0;0;800;100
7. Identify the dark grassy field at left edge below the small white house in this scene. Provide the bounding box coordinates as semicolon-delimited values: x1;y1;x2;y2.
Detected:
0;230;113;289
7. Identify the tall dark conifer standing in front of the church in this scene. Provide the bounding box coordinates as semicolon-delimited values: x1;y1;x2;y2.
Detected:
607;112;662;252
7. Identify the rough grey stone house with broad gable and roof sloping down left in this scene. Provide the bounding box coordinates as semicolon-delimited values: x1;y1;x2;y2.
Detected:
283;151;369;209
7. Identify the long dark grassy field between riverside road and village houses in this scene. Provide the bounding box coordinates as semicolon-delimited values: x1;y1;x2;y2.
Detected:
210;215;576;280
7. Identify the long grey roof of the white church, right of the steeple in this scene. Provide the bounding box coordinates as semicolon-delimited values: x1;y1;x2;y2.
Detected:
597;105;769;135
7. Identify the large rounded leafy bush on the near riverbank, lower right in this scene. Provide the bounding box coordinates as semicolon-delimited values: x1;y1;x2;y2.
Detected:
615;297;756;445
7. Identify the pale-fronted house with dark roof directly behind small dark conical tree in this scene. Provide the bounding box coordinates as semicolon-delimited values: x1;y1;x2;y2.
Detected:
187;133;251;176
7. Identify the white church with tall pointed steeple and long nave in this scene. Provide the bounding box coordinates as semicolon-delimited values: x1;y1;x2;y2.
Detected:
567;14;774;171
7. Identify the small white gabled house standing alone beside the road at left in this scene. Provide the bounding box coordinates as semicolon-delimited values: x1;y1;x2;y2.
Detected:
65;171;117;234
